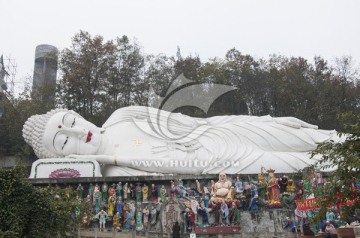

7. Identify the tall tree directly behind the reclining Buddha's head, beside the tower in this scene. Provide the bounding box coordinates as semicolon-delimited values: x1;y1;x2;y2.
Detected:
58;31;116;124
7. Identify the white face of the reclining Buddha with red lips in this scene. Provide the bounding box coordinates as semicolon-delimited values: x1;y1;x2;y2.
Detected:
43;112;101;156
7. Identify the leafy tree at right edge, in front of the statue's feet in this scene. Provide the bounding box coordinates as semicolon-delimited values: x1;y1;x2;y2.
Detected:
312;113;360;220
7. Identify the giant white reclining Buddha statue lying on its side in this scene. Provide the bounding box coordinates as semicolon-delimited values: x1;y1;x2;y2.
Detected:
23;106;339;176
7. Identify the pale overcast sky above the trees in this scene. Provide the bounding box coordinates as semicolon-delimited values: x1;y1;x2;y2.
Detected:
0;0;360;94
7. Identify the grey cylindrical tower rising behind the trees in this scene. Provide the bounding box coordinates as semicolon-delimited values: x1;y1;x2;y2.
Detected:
32;45;58;100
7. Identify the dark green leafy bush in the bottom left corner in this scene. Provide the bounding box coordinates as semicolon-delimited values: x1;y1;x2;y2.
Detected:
0;167;90;238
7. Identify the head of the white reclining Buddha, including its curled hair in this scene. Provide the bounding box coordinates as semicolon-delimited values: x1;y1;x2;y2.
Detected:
23;109;101;159
